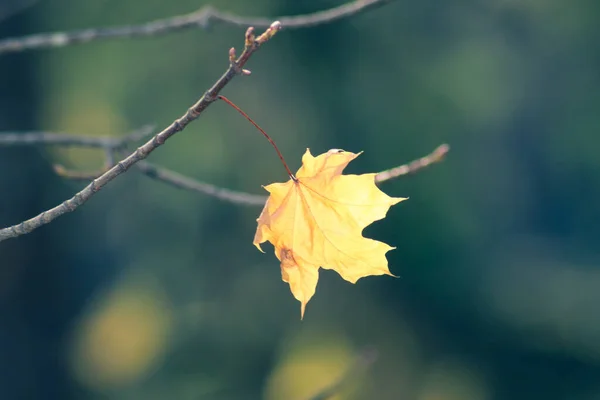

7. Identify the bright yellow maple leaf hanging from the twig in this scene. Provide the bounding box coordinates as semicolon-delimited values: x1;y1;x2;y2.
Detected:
254;149;406;318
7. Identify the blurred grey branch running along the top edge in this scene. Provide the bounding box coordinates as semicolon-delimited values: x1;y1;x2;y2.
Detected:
0;0;392;54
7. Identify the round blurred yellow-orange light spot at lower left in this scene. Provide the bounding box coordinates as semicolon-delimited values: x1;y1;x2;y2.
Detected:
71;276;171;389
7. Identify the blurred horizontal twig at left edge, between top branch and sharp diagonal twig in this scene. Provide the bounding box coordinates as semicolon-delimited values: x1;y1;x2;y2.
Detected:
0;125;154;149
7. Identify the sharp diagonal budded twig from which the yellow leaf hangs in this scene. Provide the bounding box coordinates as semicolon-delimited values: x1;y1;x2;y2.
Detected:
0;21;281;241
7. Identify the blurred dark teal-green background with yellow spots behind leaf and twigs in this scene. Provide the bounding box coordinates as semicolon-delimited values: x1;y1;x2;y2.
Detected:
0;0;600;400
